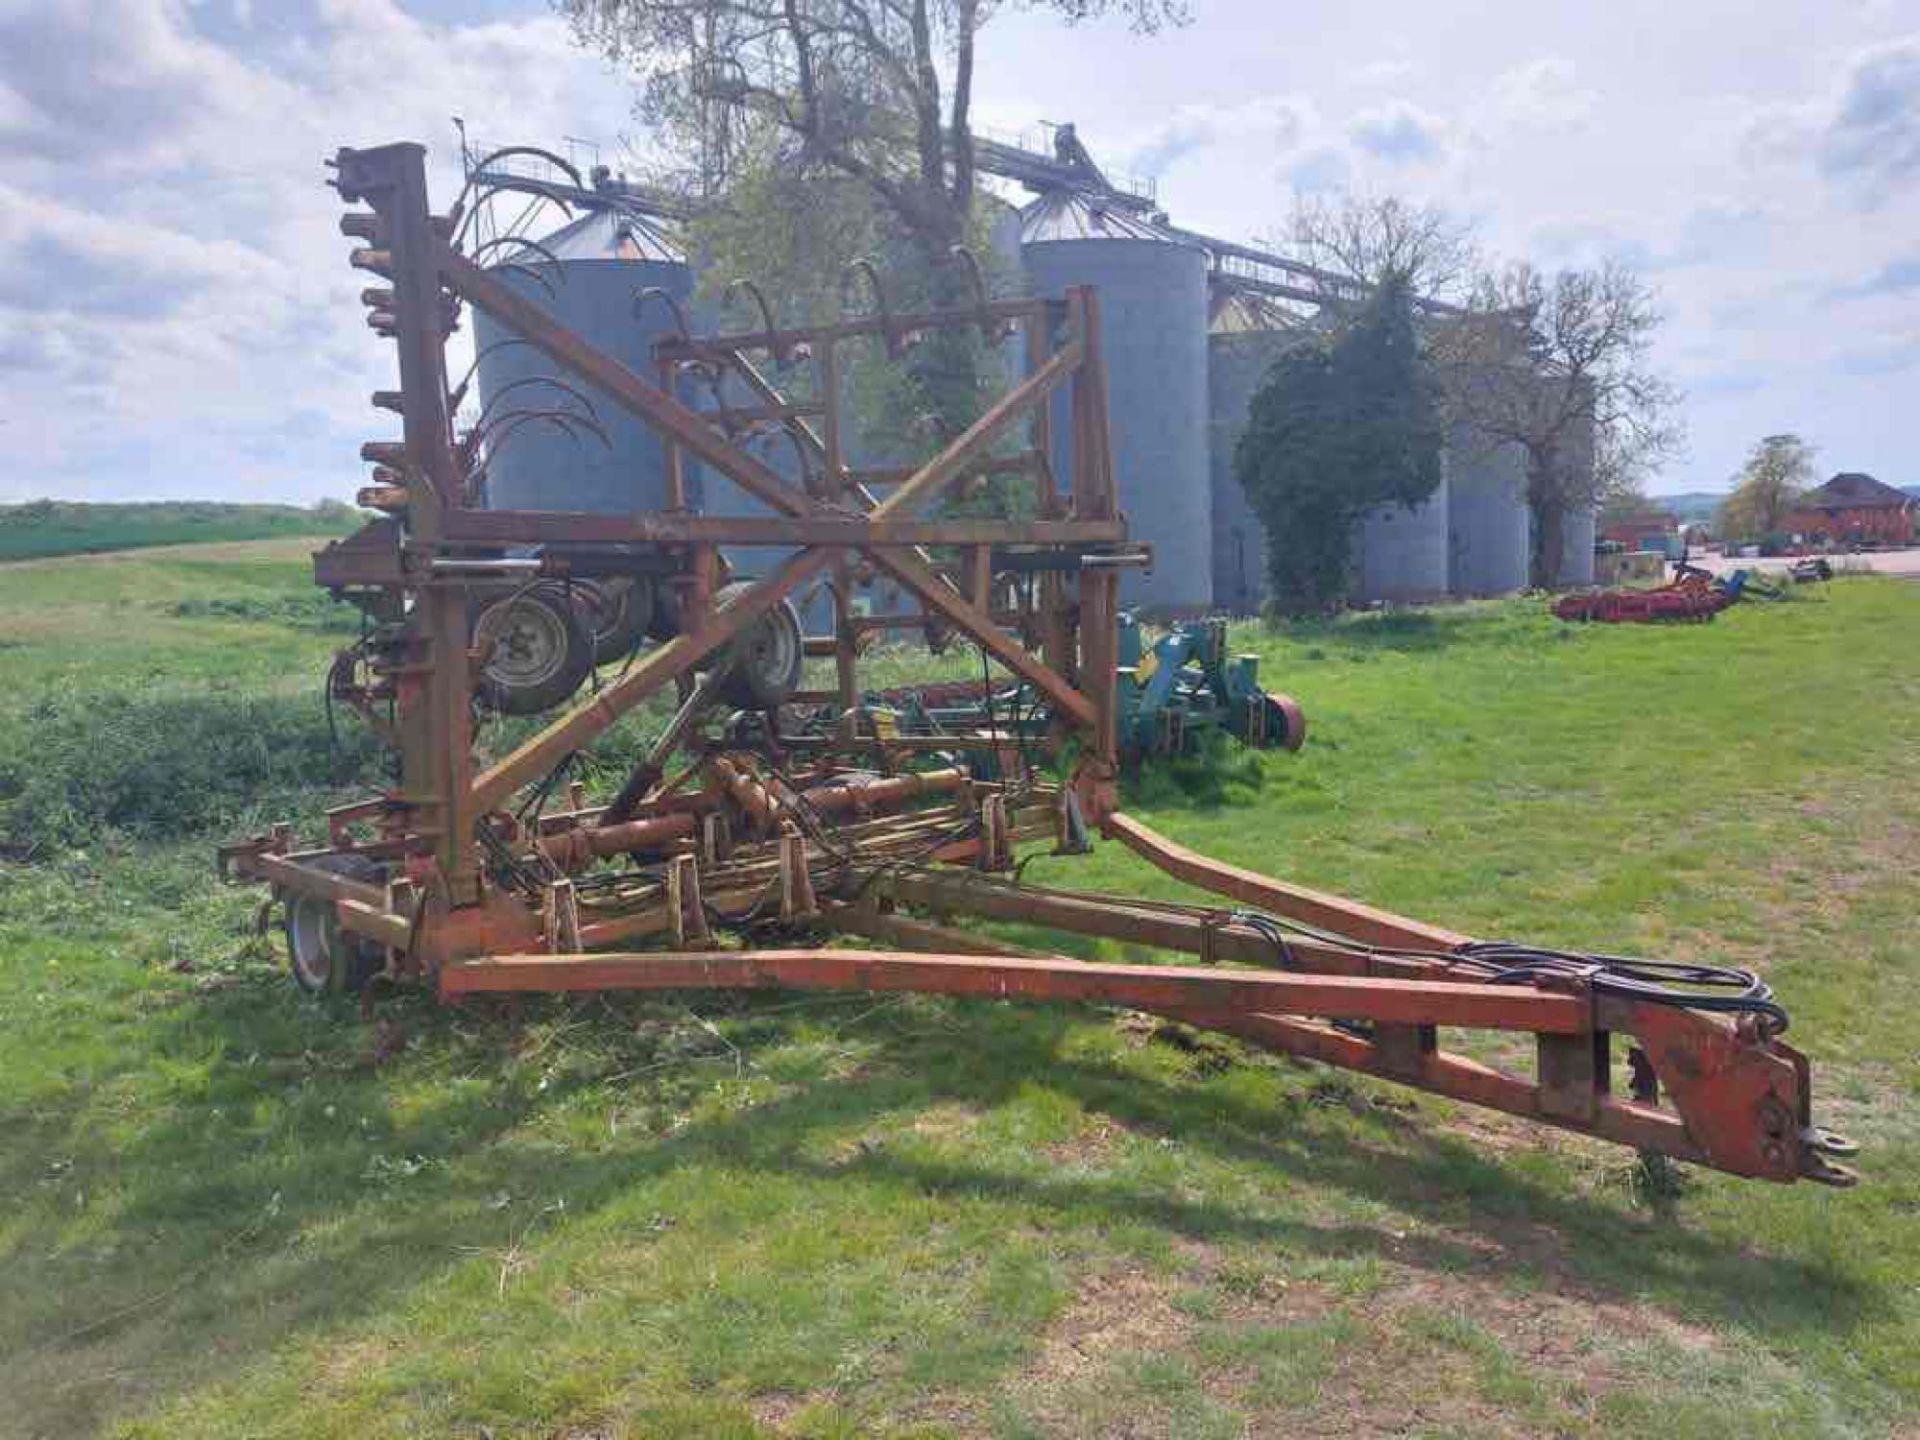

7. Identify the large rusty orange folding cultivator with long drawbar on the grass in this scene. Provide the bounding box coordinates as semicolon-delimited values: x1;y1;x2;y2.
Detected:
223;144;1853;1185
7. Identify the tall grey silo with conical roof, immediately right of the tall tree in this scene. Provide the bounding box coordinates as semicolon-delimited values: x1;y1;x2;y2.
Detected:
1021;188;1213;612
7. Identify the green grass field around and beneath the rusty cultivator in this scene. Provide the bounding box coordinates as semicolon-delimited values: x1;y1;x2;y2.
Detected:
0;541;1920;1440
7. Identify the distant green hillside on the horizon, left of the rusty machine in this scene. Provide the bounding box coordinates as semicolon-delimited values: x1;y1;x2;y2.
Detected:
0;499;359;561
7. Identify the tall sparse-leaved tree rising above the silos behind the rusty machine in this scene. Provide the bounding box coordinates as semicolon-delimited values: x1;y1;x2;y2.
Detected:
555;0;1185;459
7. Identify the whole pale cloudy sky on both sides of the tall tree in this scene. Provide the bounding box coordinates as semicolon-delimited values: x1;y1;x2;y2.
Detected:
0;0;1920;501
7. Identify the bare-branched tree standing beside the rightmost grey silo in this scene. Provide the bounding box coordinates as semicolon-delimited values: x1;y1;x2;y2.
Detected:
1434;261;1686;586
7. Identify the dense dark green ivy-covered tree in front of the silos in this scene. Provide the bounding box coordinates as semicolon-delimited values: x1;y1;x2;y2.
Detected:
1233;284;1440;611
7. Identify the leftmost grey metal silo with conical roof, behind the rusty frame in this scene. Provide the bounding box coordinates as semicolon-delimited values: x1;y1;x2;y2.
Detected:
474;207;697;515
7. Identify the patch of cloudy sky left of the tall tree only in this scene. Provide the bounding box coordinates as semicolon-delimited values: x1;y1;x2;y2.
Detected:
0;0;628;499
